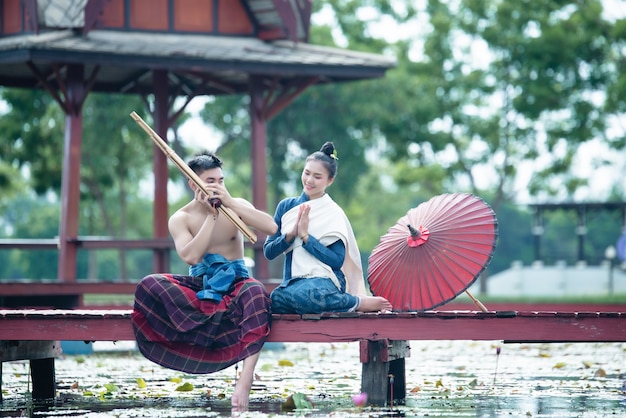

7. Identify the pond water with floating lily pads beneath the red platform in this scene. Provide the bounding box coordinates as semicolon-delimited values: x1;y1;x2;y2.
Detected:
0;341;626;418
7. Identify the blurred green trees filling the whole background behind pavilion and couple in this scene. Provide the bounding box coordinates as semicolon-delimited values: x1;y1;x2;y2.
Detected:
0;0;626;277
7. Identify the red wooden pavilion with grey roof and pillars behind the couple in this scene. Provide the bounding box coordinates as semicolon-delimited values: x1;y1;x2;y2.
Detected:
0;0;395;298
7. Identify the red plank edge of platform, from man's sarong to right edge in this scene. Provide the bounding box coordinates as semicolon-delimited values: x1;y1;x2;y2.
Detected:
271;312;626;342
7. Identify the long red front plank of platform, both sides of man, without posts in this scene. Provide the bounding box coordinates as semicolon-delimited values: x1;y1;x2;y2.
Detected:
0;310;626;342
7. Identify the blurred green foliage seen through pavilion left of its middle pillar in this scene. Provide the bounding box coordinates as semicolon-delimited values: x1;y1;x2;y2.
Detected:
0;89;153;279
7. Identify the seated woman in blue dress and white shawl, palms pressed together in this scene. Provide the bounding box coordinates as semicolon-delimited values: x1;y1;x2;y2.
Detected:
263;142;392;314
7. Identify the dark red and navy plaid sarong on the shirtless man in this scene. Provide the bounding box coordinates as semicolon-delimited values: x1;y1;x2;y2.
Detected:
131;274;270;373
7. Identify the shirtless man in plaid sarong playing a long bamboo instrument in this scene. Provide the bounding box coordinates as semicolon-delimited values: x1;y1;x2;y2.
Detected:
132;152;277;410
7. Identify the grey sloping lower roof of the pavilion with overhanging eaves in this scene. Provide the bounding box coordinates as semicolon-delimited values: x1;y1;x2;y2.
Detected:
0;29;395;95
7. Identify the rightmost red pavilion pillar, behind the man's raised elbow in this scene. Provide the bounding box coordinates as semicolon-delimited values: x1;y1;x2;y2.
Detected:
250;76;270;281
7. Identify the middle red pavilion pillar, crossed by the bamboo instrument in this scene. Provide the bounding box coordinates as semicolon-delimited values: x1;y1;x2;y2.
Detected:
152;70;169;273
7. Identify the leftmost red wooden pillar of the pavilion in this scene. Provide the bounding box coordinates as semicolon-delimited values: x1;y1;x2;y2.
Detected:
57;65;86;282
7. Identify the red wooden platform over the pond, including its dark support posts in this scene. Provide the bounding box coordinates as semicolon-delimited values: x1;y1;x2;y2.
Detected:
0;309;626;405
